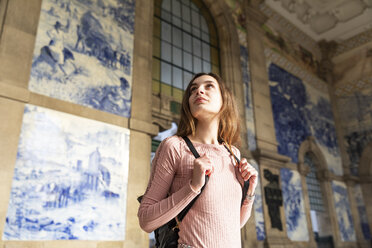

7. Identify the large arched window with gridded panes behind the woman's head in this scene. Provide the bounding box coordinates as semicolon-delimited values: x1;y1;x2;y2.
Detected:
152;0;220;103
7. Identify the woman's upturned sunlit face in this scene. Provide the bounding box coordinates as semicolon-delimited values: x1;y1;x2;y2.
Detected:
189;75;222;120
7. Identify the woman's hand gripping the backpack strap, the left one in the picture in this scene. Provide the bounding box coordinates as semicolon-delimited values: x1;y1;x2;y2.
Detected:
191;154;213;191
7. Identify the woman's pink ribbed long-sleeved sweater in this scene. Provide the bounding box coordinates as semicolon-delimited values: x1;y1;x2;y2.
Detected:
138;136;254;248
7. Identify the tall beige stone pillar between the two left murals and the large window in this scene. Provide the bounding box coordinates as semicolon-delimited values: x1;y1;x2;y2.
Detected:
124;0;158;248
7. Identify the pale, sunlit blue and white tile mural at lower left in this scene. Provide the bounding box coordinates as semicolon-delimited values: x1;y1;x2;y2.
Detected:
3;105;129;240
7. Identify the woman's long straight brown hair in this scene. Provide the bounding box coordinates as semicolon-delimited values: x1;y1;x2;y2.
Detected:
177;72;240;146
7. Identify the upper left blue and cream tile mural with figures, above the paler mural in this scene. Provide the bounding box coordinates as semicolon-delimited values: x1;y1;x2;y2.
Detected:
29;0;135;117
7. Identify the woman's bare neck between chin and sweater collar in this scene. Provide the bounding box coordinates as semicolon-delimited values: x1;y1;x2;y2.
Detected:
191;117;219;144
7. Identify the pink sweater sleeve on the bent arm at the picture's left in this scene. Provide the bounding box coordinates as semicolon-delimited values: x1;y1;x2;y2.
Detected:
138;136;200;232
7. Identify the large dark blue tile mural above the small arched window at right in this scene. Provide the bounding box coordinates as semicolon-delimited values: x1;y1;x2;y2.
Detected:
269;64;343;175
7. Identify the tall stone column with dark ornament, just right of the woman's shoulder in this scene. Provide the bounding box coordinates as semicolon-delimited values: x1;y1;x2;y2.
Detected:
243;0;292;247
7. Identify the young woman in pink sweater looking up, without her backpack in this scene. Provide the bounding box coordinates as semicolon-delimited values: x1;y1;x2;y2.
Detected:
138;73;257;248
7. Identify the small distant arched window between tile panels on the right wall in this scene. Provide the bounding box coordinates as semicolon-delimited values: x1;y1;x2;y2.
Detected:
304;152;325;212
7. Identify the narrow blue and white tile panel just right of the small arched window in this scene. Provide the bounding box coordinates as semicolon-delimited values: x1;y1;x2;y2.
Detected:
332;181;356;241
